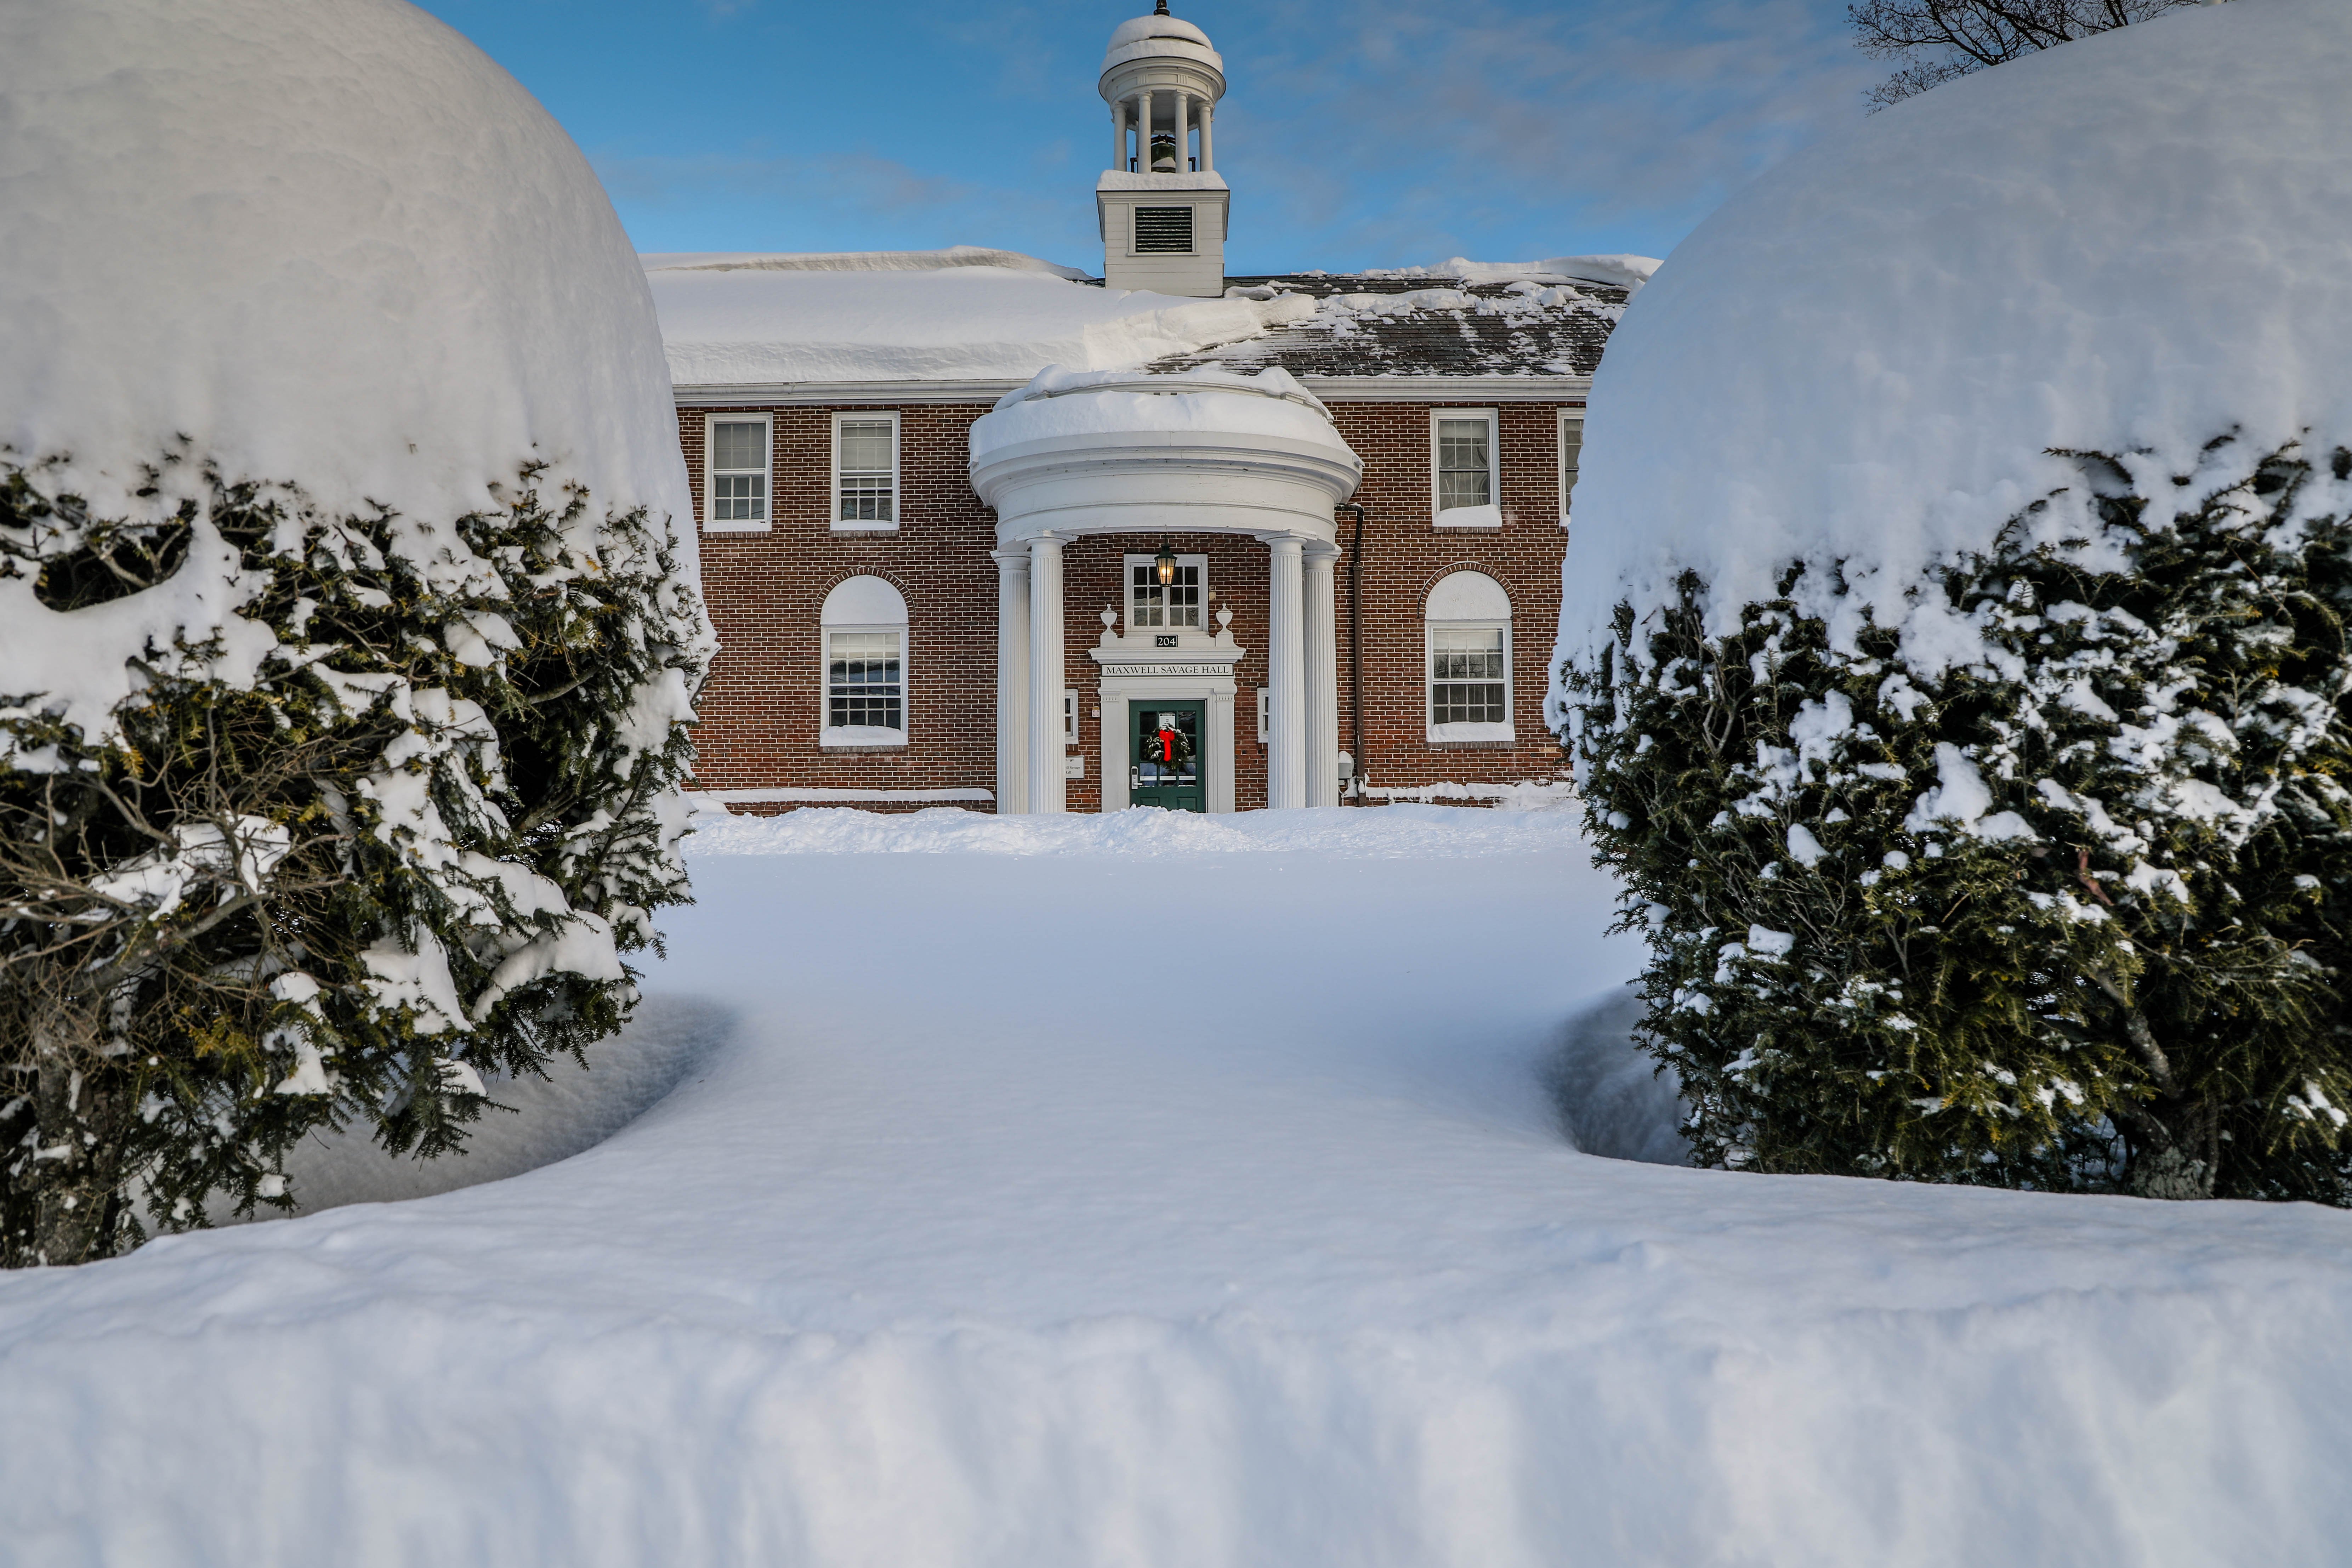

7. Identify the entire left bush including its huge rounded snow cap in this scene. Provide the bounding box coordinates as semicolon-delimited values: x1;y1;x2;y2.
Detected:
0;0;710;1262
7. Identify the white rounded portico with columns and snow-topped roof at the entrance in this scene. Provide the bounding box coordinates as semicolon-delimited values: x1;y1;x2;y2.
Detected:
971;369;1364;813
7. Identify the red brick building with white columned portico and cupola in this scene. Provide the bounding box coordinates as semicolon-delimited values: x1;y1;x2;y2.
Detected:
647;10;1642;811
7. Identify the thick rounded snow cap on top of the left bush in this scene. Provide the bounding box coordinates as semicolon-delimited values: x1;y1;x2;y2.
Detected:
0;0;692;533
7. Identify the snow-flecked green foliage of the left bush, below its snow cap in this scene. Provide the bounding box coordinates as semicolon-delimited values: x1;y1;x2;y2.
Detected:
0;461;708;1265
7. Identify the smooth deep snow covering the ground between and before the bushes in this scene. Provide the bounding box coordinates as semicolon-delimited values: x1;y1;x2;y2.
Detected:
0;806;2352;1568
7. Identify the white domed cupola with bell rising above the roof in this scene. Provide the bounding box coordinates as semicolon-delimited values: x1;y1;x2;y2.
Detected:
1094;0;1230;299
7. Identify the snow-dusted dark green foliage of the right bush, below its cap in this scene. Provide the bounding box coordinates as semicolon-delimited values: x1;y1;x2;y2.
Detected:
1562;439;2352;1204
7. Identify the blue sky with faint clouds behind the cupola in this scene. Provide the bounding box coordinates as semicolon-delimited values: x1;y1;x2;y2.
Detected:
404;0;1882;275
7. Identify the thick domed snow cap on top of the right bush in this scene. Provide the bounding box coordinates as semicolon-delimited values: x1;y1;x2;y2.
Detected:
1562;0;2352;667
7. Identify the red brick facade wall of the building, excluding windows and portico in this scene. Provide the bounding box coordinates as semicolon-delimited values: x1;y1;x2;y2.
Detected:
680;402;1567;811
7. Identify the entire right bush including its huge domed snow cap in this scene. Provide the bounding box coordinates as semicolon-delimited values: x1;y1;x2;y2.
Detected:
1552;0;2352;1201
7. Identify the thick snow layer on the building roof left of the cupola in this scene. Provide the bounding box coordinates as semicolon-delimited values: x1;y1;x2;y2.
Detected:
644;249;1312;388
